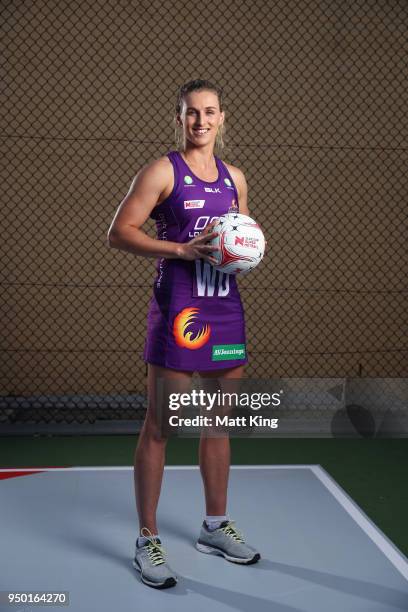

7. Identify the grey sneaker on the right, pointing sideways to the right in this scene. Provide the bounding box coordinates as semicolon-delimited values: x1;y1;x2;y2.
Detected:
196;521;261;565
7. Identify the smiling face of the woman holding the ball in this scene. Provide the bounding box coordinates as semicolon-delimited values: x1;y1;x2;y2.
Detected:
179;90;224;146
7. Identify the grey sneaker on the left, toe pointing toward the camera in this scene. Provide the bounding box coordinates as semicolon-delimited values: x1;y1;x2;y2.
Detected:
133;527;177;589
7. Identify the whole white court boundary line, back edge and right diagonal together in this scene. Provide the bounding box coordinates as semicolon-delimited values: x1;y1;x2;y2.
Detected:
0;464;408;581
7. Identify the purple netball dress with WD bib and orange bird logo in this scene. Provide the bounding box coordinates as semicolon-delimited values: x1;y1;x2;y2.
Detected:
143;151;247;371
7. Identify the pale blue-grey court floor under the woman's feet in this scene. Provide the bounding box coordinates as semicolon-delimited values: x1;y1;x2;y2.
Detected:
0;466;408;612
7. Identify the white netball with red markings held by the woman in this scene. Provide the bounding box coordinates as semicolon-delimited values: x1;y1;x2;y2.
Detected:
209;212;265;274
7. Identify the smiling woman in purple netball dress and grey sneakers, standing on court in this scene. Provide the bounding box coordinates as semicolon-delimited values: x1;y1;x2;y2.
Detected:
108;80;260;588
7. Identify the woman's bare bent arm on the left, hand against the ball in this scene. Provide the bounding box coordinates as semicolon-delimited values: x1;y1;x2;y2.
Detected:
107;159;217;263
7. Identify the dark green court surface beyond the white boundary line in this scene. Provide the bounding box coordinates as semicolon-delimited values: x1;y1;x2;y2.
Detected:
0;435;408;555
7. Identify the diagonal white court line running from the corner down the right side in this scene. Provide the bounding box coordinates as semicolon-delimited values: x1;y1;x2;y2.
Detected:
310;465;408;581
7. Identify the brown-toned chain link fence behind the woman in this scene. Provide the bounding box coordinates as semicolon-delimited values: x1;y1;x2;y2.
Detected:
0;0;408;432
